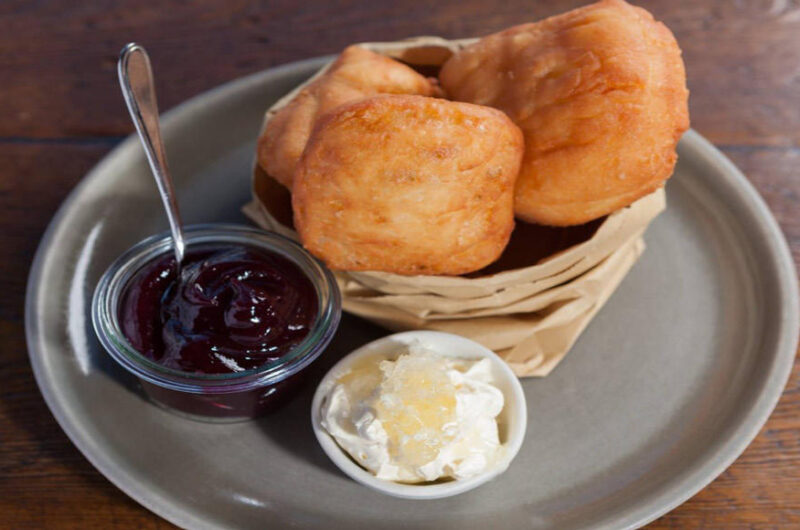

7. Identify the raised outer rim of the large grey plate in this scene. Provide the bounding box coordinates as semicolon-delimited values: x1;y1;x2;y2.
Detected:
25;56;800;528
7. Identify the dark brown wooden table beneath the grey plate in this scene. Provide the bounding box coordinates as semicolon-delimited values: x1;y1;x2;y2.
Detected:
0;0;800;529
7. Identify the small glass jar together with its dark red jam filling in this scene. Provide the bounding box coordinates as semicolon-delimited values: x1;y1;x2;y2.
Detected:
92;224;341;422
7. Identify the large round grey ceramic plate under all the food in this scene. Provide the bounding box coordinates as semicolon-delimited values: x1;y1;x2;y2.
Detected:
26;59;800;530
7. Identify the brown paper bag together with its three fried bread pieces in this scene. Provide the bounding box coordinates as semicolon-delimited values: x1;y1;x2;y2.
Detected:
245;0;688;376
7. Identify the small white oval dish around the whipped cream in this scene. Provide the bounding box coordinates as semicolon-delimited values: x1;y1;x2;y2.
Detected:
311;331;528;499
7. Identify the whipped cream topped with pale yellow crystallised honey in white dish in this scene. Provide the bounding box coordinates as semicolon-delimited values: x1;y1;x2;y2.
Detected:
321;343;504;483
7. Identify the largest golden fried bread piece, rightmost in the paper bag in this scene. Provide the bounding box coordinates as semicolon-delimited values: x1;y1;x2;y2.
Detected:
439;0;689;226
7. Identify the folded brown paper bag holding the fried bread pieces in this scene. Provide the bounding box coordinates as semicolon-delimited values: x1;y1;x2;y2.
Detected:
243;37;666;377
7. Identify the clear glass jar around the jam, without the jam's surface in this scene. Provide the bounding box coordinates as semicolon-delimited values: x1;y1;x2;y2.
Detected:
92;224;341;422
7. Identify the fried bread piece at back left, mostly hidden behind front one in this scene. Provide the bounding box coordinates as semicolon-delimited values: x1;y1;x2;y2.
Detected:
258;46;438;189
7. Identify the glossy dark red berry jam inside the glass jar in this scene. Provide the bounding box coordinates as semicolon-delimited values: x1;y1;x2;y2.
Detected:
119;246;318;374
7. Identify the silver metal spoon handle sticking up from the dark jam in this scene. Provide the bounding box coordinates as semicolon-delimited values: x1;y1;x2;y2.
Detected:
117;42;185;268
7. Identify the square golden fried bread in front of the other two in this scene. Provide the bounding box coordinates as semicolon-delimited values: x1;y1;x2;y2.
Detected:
292;95;522;274
